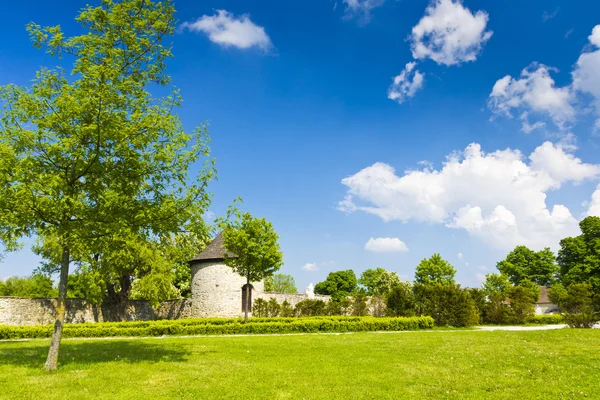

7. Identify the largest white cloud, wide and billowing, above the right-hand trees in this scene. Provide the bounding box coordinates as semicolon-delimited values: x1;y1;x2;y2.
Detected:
338;142;600;249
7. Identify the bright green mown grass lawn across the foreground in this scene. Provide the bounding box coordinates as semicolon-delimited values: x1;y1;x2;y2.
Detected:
0;329;600;400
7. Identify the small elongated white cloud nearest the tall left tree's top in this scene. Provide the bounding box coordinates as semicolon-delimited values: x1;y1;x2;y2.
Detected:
181;10;271;50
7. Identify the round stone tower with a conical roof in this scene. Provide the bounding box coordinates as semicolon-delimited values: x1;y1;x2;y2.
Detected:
189;233;264;318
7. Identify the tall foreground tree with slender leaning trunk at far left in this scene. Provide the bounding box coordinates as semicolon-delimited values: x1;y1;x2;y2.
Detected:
0;0;214;370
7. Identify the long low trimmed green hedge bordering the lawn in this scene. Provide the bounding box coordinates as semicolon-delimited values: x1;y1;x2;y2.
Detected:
0;317;434;339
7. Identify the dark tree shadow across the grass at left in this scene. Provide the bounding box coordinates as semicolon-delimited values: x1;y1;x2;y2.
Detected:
0;340;208;368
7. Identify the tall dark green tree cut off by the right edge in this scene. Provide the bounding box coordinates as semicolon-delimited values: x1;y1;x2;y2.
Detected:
557;217;600;294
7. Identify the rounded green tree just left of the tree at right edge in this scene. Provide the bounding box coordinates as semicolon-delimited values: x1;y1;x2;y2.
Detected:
496;246;558;286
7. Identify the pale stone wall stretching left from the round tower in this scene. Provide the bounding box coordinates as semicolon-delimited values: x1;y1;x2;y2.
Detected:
0;297;192;325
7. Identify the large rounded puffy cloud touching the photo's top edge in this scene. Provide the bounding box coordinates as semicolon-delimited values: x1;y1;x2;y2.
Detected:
410;0;492;65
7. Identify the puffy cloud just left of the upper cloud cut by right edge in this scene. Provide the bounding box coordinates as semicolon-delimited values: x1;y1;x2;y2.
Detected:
488;63;575;133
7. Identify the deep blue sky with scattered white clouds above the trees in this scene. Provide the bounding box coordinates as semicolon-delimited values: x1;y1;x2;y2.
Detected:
0;0;600;290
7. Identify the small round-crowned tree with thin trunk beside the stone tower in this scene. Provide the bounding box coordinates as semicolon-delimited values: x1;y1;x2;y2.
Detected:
223;213;283;322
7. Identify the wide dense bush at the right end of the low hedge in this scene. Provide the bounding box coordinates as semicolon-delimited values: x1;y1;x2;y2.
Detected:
414;284;479;327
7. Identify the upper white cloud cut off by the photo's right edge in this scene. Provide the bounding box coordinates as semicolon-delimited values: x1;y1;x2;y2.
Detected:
573;25;600;129
